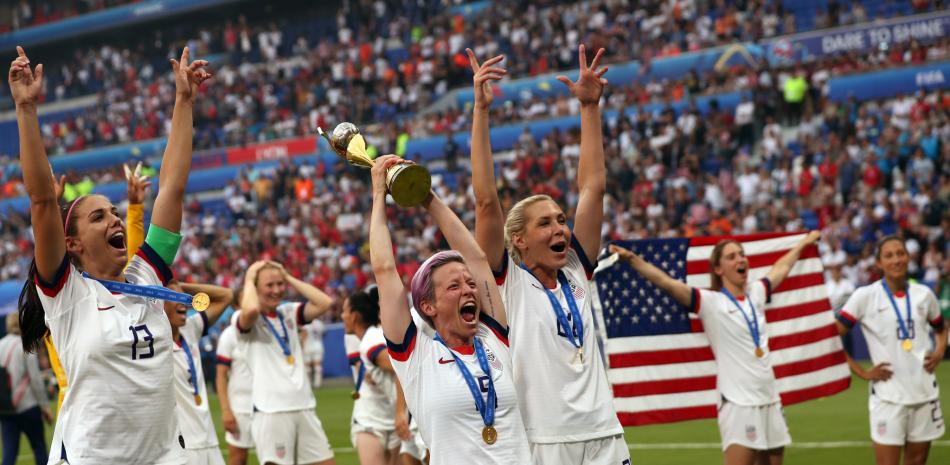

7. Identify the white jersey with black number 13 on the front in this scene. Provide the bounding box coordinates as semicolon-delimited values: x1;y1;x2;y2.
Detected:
36;243;185;465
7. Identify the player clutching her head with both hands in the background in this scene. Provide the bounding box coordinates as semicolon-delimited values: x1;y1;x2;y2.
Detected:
236;261;335;465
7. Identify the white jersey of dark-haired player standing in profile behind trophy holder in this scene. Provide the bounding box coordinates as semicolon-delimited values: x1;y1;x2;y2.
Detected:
353;326;396;431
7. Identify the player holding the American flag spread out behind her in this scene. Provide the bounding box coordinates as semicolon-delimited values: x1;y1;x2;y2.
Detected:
610;231;821;465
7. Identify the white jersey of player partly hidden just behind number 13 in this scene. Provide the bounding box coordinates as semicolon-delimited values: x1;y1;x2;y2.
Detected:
172;312;218;449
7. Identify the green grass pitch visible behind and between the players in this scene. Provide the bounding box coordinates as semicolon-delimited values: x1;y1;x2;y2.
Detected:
9;361;950;465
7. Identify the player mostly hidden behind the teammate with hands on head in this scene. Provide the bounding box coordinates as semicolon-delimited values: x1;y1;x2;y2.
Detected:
215;318;254;465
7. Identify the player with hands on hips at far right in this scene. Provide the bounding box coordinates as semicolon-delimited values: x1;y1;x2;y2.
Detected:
838;236;947;465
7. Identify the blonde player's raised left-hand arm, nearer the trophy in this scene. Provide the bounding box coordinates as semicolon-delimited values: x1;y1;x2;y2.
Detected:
465;48;507;270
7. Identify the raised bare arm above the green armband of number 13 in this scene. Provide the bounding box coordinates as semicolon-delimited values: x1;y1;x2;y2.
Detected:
152;47;211;233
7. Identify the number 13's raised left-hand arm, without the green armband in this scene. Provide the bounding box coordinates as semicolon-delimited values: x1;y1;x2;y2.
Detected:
7;46;66;281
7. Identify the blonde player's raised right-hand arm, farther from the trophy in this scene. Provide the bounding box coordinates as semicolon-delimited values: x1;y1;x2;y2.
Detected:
557;45;607;263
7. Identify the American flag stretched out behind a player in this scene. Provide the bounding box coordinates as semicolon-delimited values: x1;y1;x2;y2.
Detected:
596;233;851;426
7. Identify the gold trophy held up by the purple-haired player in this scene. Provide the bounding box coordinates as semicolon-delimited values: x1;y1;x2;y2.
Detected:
317;123;432;207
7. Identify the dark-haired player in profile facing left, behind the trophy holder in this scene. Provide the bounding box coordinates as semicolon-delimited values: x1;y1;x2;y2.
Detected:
342;288;399;465
